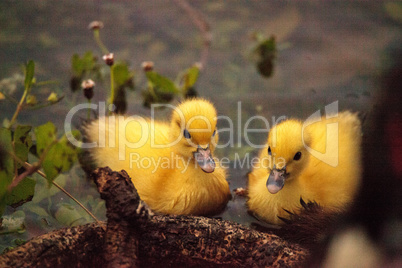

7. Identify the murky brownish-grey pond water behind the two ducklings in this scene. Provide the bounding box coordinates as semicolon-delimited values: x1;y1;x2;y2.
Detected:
0;0;401;249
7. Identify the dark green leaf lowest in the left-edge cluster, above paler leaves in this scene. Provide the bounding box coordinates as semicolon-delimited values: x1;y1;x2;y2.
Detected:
5;177;36;208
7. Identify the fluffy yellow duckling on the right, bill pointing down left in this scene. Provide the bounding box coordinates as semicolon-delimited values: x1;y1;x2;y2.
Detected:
247;112;361;224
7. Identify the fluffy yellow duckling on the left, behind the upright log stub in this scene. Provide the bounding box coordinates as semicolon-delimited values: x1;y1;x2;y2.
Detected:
85;98;231;215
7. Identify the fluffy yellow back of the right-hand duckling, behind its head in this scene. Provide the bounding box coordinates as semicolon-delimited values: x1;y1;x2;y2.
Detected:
300;112;361;208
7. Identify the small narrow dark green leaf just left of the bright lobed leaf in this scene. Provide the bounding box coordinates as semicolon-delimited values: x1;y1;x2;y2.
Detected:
14;125;32;168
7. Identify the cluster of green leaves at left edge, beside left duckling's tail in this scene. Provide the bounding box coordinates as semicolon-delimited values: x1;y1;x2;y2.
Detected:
0;122;79;216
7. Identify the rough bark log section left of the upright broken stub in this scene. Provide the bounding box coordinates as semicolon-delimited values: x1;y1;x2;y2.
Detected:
0;223;105;267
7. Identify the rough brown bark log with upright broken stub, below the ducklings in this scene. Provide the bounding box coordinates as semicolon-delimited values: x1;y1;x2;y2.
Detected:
0;168;308;267
